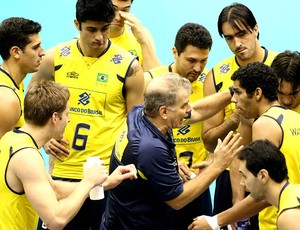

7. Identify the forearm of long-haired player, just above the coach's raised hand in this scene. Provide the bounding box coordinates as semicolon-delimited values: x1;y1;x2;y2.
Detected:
202;114;239;152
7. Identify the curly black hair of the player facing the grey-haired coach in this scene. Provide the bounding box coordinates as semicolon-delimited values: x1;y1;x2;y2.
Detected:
231;62;278;102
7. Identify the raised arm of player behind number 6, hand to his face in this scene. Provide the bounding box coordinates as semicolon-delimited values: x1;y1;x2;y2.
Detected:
120;11;161;71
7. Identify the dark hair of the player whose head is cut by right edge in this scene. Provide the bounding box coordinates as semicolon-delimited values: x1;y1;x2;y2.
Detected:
271;50;300;92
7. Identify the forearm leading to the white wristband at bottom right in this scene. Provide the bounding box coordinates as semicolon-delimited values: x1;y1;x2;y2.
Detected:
218;195;270;226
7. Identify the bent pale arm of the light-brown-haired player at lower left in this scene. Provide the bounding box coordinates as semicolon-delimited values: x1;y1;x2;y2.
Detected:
9;149;107;229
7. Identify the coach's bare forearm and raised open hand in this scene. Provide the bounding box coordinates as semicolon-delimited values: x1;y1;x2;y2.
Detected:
166;132;243;209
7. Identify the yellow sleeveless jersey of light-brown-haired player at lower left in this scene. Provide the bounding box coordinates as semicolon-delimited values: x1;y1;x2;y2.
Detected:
0;129;42;230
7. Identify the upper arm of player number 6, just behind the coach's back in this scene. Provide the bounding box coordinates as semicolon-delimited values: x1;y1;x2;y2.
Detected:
125;60;144;112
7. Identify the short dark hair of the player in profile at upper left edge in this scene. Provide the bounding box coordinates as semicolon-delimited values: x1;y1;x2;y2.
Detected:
0;17;42;60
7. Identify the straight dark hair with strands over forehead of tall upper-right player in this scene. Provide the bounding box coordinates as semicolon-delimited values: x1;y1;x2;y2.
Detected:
218;3;259;39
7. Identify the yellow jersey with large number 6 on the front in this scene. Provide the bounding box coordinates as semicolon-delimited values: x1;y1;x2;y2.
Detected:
53;39;136;179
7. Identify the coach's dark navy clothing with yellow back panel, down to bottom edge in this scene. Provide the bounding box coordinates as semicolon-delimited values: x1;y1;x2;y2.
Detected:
101;105;183;230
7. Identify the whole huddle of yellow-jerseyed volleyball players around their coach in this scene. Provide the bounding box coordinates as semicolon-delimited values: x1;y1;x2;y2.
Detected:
0;0;300;230
